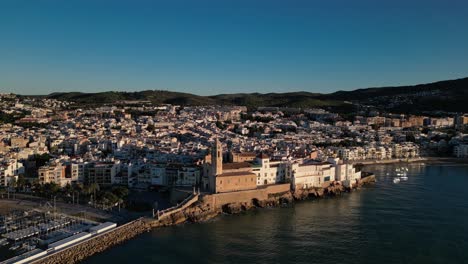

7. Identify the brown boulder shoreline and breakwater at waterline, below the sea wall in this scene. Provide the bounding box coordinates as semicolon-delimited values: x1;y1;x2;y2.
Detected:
33;175;375;264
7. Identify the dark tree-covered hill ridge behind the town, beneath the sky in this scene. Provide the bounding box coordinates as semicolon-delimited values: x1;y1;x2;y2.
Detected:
32;78;468;112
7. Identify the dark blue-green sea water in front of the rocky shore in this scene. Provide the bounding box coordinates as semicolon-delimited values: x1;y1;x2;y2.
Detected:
86;164;468;264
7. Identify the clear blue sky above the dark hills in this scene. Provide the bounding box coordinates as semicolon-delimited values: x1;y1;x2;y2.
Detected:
0;0;468;95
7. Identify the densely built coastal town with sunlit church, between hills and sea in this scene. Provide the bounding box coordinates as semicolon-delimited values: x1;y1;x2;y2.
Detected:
0;94;468;263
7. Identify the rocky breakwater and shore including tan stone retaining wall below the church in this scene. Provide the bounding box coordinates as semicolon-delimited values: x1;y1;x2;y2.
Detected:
33;175;375;264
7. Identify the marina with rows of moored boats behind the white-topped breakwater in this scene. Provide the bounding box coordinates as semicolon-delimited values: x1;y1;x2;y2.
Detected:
0;209;117;264
